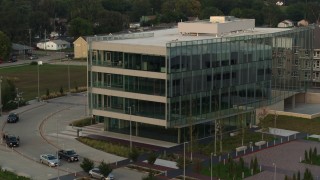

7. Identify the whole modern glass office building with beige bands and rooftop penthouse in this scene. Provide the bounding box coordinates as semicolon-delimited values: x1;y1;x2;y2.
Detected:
87;16;313;143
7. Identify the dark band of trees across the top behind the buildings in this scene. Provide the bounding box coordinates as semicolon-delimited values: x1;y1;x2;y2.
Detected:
0;0;320;42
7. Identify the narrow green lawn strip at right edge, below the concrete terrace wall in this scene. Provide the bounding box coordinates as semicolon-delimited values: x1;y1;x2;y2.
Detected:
266;115;320;134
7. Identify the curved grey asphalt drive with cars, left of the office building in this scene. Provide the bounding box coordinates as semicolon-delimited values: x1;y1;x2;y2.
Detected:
0;94;145;180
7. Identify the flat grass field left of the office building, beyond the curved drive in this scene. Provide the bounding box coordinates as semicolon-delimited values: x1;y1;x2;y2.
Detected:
0;64;87;100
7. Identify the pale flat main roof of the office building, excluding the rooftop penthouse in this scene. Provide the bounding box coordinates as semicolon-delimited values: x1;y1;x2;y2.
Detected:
99;27;292;47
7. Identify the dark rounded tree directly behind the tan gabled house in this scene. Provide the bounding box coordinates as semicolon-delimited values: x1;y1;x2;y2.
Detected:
68;17;93;37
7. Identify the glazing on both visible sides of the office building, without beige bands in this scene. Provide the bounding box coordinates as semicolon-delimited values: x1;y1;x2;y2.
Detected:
88;27;313;143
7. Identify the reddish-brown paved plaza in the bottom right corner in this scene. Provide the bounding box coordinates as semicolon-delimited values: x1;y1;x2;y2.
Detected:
243;140;320;180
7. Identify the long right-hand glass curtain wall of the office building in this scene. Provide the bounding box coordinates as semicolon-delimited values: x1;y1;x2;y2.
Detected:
167;28;312;127
